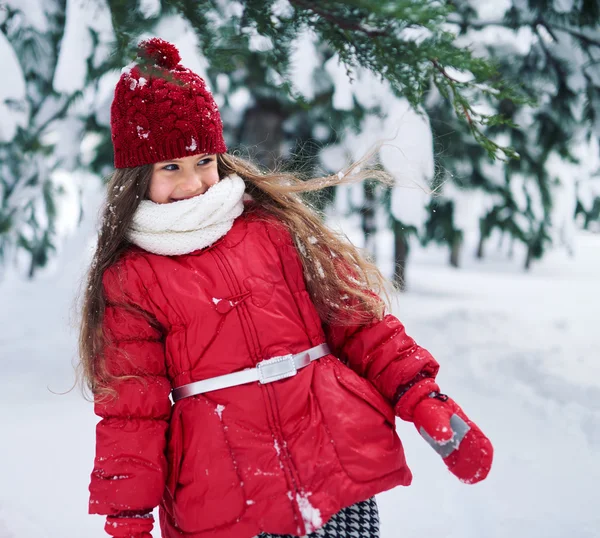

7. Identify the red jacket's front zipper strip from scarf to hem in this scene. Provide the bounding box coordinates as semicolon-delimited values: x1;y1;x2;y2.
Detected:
210;248;306;534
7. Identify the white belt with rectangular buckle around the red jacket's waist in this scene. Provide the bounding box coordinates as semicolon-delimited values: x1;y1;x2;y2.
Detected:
172;344;331;402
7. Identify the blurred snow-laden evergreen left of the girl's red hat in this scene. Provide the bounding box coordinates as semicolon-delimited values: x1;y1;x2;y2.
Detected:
0;0;155;276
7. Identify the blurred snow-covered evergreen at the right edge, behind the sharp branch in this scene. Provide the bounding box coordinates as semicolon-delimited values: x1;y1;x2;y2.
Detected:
426;0;600;268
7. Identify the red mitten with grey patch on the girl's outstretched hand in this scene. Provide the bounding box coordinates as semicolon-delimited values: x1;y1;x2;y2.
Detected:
396;379;494;484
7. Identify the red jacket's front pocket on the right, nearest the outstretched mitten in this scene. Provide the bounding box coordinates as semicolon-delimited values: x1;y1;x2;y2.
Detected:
313;358;406;482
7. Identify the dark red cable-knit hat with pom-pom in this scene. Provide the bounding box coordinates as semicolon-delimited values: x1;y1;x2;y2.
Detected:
110;38;227;168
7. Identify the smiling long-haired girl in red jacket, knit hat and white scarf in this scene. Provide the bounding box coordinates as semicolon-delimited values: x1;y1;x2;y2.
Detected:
80;39;492;538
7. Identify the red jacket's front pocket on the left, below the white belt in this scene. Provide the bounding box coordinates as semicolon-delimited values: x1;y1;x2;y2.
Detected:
169;396;246;533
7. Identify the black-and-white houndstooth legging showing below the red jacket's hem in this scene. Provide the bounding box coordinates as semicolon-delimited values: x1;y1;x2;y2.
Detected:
256;497;379;538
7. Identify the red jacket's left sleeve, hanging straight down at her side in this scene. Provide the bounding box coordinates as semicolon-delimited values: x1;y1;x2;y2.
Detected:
89;263;171;536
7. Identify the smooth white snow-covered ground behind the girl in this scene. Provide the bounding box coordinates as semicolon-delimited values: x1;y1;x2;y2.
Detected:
0;182;600;538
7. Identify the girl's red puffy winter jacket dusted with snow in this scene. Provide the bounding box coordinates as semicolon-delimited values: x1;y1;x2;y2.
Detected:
90;207;438;538
